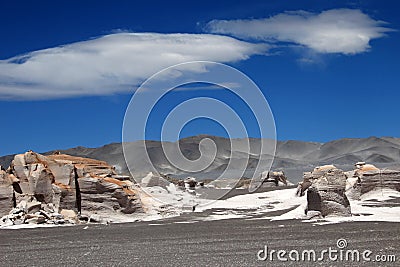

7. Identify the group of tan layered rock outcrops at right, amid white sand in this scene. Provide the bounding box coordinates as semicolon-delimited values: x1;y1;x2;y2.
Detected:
296;162;400;221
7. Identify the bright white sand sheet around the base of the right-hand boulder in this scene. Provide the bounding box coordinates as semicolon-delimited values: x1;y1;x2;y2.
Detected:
196;189;400;224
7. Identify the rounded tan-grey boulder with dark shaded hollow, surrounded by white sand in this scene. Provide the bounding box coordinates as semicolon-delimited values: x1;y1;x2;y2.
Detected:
297;165;351;217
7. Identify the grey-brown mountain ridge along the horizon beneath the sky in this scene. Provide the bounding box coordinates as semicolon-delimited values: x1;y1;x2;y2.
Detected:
0;135;400;182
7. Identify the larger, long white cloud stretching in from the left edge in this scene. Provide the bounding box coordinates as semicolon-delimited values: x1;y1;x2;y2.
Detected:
0;33;268;100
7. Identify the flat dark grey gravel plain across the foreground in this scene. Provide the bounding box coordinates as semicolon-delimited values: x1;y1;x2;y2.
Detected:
0;217;400;266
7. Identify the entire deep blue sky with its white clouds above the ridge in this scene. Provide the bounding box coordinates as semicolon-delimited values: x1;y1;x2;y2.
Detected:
0;1;400;155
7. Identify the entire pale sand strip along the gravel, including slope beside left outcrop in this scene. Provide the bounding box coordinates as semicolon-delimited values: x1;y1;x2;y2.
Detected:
4;185;400;229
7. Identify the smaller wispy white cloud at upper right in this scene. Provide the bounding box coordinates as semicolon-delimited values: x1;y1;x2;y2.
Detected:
206;9;393;54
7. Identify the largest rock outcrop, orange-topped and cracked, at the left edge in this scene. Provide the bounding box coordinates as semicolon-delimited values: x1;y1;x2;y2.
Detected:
0;151;141;224
